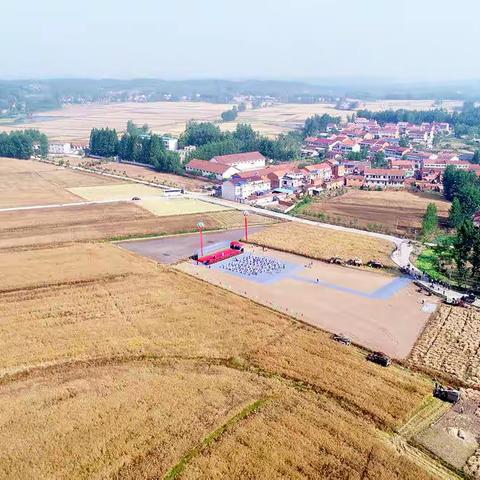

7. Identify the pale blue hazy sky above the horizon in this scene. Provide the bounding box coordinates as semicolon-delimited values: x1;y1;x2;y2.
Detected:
0;0;480;81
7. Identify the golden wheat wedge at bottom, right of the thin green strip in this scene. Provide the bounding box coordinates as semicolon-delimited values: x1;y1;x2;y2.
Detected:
182;391;433;480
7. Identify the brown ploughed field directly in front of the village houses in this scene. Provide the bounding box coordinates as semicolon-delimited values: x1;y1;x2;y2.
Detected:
302;190;450;235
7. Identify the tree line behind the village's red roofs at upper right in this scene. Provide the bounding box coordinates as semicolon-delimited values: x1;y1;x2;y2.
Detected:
357;102;480;137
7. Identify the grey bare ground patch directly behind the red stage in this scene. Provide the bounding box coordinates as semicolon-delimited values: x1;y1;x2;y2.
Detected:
117;227;265;264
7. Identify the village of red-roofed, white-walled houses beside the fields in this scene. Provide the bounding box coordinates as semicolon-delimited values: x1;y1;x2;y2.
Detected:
185;117;480;210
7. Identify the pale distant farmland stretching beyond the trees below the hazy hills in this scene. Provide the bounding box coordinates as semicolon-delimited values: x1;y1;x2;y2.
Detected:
0;100;461;143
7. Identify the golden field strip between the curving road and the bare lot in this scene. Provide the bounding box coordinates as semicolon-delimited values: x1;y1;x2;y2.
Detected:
249;222;395;267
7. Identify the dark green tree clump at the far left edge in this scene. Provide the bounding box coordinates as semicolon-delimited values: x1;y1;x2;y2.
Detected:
0;129;48;160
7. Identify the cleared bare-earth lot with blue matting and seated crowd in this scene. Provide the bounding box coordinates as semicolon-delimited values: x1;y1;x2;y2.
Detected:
177;246;436;358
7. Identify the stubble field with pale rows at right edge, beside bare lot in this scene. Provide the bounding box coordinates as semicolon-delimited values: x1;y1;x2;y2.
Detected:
409;305;480;388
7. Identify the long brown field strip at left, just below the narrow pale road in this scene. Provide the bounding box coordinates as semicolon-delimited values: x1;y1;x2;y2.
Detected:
0;202;275;251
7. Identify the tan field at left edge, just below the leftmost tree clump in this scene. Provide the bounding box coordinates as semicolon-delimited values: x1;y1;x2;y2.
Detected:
0;158;125;208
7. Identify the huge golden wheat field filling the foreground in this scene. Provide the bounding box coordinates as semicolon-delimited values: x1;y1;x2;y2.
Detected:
0;244;444;479
